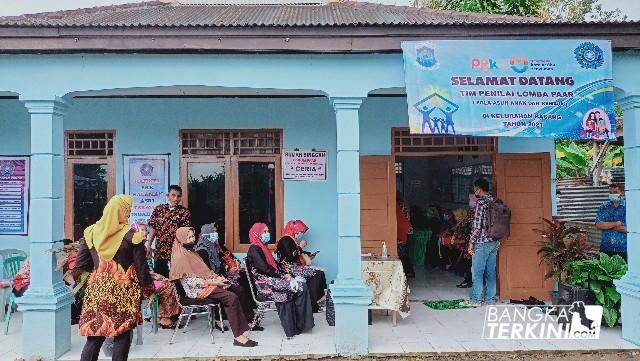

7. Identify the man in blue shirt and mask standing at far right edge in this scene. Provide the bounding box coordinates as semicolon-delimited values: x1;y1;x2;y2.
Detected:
596;184;627;261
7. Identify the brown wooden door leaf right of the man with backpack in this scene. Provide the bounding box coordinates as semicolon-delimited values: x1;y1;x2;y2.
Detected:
495;153;553;300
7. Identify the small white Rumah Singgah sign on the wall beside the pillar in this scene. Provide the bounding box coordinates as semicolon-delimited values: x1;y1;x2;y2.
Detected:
282;149;327;181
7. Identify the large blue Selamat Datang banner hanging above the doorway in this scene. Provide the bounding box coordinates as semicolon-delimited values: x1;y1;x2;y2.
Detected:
402;39;616;140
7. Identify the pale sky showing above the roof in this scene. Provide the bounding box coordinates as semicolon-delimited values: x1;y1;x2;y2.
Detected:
0;0;640;20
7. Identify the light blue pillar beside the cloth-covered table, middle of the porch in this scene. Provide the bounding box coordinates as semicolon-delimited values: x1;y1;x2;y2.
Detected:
331;98;371;355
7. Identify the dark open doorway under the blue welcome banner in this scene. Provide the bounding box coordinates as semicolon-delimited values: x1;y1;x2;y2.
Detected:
395;154;494;299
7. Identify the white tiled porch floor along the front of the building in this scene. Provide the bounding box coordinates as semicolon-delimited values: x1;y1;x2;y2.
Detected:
0;270;640;361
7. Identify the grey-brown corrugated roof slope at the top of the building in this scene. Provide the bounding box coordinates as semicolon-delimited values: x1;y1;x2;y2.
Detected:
0;1;547;27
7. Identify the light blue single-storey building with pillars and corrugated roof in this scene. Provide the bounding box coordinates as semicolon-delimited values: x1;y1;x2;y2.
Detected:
0;2;640;358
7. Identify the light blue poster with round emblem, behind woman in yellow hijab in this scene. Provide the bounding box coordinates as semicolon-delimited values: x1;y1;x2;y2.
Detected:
124;154;169;224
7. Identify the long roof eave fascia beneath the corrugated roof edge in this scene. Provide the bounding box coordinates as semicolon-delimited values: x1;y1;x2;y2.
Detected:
0;23;640;53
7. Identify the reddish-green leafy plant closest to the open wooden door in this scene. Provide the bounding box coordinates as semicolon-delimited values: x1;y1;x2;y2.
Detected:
535;219;597;282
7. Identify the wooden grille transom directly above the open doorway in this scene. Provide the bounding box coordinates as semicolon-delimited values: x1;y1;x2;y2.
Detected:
393;128;498;154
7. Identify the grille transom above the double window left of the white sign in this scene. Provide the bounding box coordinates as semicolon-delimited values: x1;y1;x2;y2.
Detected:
181;129;282;156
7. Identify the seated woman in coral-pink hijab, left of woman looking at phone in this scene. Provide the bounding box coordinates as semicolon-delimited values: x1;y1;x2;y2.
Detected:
247;223;314;338
